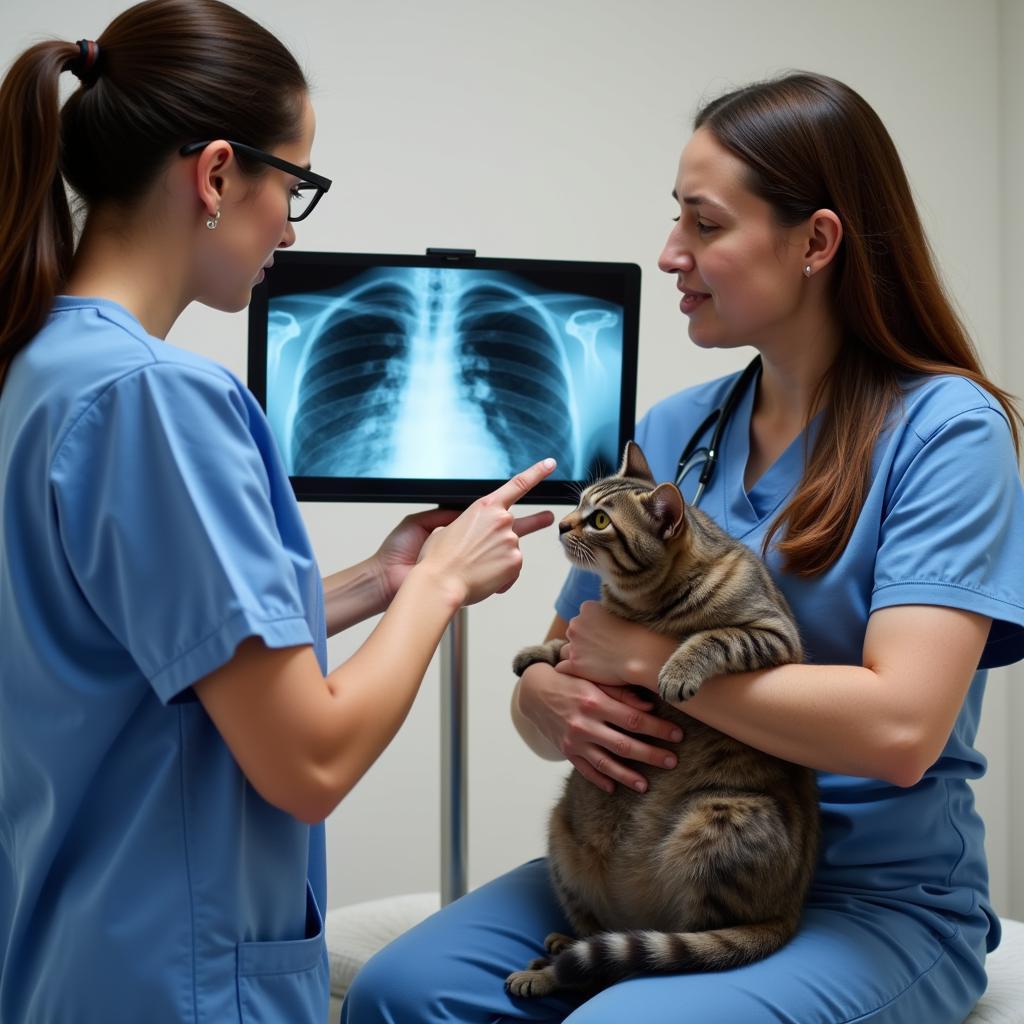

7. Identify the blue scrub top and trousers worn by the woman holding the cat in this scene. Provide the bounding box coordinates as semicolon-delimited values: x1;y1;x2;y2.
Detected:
342;368;1024;1024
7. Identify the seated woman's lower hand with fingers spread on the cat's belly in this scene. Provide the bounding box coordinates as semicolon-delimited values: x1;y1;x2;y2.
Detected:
518;664;682;793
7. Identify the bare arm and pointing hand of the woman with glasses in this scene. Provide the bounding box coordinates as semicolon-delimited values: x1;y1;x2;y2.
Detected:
195;463;553;822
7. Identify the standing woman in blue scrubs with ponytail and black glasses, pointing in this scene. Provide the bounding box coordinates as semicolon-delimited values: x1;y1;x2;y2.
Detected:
0;0;553;1024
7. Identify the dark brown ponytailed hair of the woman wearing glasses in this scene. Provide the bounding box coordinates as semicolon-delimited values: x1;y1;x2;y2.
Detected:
0;0;307;383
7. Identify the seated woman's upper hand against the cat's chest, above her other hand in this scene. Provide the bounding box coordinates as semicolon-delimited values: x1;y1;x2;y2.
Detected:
557;601;679;693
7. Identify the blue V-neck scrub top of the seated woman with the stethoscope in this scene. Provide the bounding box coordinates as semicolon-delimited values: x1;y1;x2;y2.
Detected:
556;376;1024;950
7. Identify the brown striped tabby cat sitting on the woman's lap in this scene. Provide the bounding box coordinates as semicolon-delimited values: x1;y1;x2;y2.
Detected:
506;441;819;996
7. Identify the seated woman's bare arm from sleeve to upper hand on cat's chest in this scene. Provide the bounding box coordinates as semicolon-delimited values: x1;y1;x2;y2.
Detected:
555;602;991;785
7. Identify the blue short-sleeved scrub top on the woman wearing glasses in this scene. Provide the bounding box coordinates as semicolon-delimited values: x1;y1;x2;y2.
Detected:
0;298;328;1024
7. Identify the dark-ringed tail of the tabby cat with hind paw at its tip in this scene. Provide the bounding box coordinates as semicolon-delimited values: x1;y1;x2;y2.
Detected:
506;920;798;996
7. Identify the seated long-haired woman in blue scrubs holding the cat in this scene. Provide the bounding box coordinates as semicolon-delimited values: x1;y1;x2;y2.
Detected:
343;75;1024;1024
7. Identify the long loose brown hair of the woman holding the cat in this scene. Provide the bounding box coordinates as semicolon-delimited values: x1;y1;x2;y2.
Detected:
693;73;1024;577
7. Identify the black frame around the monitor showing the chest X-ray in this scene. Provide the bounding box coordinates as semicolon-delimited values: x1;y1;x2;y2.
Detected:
248;250;640;507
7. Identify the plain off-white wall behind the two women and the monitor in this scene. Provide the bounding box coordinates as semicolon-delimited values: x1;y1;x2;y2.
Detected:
0;0;1024;918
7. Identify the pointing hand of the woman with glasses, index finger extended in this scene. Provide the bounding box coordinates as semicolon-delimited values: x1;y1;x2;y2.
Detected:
417;459;555;604
